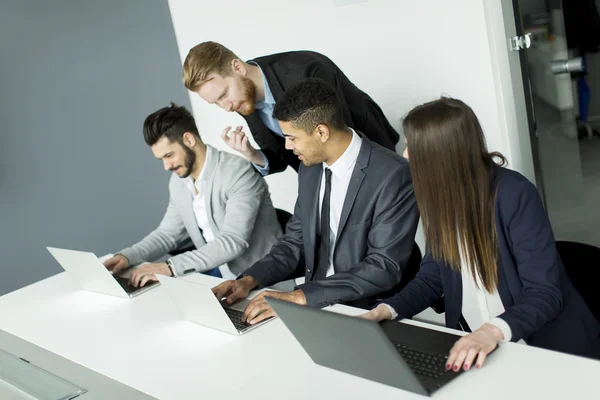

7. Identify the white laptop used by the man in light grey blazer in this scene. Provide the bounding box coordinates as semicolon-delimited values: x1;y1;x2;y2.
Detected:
47;247;158;299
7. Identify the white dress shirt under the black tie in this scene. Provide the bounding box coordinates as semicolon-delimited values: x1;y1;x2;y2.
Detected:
317;129;362;276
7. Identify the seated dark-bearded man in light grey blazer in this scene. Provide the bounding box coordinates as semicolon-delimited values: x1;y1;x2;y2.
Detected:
104;103;281;287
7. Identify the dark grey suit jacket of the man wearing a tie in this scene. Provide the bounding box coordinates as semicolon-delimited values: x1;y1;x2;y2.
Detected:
244;135;419;307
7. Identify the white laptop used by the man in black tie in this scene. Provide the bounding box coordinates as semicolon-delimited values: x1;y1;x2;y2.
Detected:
157;275;272;335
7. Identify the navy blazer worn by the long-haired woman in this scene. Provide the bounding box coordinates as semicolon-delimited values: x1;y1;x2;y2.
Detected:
383;167;600;358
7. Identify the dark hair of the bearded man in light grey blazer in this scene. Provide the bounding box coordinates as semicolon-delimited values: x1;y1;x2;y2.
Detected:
144;103;200;146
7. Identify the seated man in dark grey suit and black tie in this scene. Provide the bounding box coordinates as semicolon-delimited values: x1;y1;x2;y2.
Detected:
213;79;419;324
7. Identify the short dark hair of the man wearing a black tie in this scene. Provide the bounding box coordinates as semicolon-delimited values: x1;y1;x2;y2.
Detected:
273;78;347;134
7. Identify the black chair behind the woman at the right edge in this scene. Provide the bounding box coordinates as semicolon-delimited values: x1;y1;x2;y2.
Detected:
556;241;600;321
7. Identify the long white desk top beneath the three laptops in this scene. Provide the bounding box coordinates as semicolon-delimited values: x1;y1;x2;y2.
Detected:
0;273;600;400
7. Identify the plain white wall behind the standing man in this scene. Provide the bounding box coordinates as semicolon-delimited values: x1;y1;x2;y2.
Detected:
169;0;533;247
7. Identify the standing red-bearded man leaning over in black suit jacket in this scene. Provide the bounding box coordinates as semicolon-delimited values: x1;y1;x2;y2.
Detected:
183;42;399;175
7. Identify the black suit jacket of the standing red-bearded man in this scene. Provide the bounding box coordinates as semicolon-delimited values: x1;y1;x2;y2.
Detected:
243;51;399;173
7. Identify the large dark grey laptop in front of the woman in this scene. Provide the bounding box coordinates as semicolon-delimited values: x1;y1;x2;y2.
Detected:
267;298;462;396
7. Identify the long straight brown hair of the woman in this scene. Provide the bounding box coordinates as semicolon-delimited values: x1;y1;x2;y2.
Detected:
402;98;506;293
